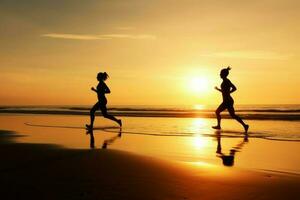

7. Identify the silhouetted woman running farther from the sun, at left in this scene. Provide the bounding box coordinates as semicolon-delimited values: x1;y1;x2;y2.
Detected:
86;72;122;130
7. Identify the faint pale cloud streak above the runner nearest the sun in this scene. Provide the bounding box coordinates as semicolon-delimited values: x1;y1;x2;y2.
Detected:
201;51;292;60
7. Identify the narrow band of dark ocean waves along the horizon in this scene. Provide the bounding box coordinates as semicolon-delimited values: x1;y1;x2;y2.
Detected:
0;104;300;121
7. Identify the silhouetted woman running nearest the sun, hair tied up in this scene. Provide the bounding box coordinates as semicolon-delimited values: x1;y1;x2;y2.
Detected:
212;67;249;133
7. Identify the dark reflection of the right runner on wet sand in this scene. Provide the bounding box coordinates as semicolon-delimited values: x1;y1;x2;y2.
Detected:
215;131;249;167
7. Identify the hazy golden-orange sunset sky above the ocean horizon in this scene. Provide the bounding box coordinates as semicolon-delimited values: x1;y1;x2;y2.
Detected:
0;0;300;105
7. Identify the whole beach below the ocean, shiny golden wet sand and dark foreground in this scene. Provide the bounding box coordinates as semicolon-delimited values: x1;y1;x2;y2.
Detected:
0;114;300;200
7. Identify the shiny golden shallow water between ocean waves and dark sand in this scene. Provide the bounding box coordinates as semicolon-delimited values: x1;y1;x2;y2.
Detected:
0;114;300;174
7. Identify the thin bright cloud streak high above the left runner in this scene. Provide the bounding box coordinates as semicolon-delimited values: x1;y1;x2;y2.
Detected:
41;33;156;40
